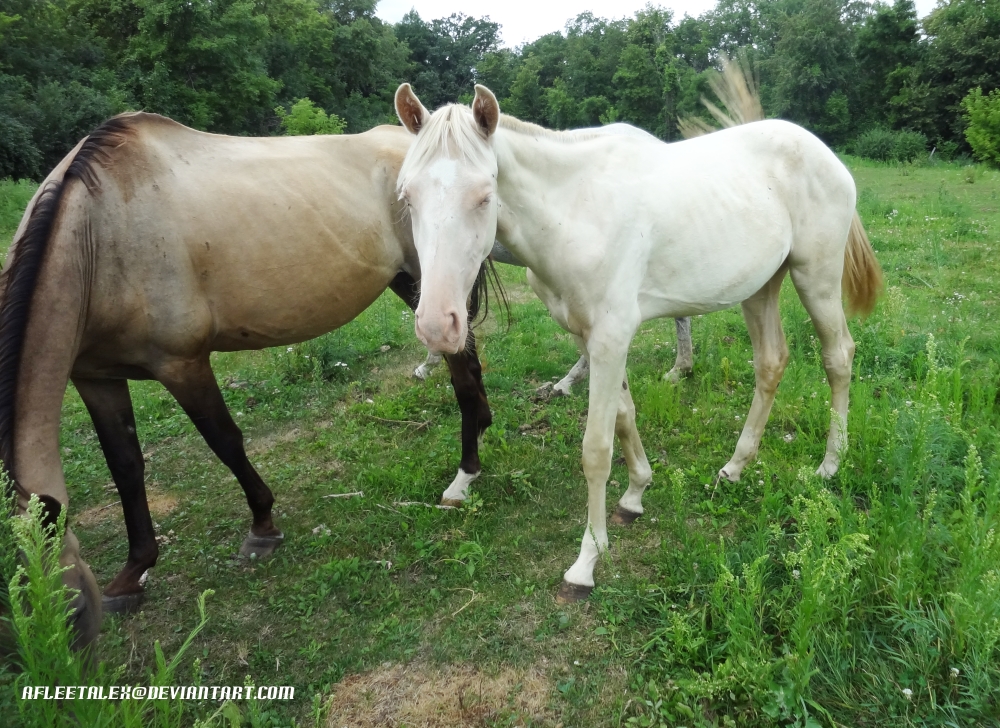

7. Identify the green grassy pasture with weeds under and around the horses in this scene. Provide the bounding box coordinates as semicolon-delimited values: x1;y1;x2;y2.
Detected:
0;159;1000;728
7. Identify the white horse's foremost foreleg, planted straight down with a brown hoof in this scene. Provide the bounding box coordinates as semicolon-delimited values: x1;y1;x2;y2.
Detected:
557;326;632;602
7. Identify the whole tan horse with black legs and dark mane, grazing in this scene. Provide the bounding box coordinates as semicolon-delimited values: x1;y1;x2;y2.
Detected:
0;113;491;643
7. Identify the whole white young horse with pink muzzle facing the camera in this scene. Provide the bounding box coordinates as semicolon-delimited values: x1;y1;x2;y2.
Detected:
396;84;881;599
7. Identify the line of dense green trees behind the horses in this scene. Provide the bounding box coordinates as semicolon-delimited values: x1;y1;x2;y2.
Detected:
0;0;1000;179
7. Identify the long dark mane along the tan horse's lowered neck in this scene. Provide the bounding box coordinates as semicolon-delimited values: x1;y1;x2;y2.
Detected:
0;114;136;496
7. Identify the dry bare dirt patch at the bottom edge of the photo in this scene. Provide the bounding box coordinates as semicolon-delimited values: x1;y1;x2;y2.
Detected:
327;662;554;728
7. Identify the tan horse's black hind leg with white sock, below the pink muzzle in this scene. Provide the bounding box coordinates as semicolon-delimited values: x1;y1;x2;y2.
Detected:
441;328;493;506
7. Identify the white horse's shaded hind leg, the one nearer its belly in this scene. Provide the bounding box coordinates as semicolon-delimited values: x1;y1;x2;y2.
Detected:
719;268;788;482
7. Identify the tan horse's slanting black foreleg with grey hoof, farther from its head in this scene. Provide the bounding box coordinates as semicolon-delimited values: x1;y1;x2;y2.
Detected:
157;356;284;558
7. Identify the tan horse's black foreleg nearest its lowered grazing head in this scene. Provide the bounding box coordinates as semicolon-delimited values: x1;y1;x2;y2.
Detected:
73;379;160;613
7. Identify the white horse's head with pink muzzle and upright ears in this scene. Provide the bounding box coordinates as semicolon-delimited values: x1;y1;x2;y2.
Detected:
396;84;500;354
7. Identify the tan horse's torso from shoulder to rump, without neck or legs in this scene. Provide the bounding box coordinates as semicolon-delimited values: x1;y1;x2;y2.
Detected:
67;114;415;376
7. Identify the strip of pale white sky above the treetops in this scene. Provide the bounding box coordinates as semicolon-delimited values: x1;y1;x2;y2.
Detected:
375;0;935;47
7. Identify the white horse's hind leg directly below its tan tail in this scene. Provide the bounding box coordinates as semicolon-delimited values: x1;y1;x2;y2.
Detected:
792;268;854;478
